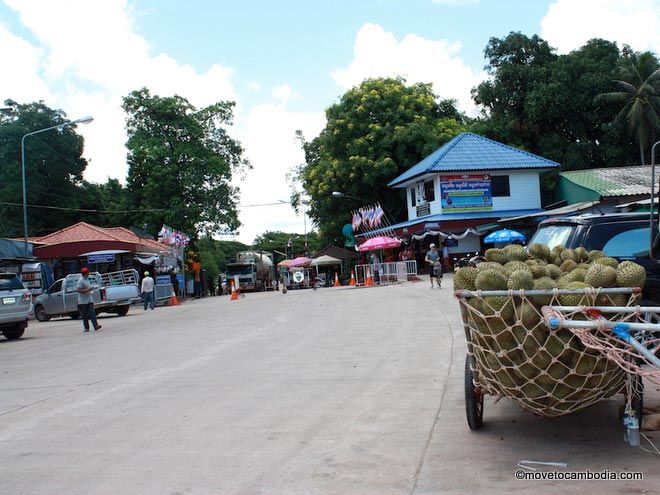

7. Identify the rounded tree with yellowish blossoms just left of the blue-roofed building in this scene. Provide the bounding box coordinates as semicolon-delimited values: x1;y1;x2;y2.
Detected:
292;78;465;242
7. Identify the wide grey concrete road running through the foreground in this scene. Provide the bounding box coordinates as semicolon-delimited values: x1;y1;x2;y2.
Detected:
0;283;660;495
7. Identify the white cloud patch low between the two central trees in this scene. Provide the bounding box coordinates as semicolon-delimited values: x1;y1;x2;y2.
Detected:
236;97;325;244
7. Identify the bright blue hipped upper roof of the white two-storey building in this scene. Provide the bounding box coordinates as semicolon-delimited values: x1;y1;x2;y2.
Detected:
388;132;559;187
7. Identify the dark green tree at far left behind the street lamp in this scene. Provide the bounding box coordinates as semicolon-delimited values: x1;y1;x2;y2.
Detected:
0;100;87;237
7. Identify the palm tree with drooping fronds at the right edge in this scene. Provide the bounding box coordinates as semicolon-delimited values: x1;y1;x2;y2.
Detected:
594;52;660;165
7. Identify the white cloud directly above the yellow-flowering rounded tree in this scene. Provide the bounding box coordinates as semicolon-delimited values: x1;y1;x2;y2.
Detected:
332;23;485;114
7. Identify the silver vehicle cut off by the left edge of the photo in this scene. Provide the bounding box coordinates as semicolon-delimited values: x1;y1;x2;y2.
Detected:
0;273;32;340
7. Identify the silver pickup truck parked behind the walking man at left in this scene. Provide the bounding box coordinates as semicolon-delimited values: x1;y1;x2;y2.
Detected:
34;270;140;321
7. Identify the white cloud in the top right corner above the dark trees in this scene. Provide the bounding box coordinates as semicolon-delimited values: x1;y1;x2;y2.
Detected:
541;0;660;53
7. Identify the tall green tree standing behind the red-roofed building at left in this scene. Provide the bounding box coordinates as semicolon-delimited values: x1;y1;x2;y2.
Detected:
123;88;249;237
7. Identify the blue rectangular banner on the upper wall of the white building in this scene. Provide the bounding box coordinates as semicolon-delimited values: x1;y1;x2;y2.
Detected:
440;174;493;213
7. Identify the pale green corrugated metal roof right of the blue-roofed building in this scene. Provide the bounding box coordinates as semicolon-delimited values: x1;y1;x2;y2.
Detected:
559;165;660;197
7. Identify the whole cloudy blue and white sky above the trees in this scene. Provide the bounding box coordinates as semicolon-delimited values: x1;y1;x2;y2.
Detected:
0;0;660;243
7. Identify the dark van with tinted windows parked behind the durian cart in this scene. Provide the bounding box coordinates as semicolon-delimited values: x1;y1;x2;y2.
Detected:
529;213;660;305
